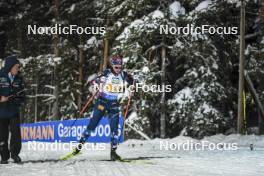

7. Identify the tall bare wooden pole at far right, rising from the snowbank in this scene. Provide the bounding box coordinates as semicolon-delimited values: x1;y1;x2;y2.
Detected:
237;0;245;133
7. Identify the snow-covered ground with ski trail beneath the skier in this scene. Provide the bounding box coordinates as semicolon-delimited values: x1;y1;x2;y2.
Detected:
0;135;264;176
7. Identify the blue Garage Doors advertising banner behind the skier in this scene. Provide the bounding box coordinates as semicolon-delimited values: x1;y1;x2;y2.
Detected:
21;117;124;143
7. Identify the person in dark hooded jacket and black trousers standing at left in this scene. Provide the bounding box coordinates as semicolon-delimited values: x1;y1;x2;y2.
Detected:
0;56;25;164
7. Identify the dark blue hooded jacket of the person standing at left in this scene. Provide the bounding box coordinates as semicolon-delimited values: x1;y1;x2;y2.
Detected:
0;56;25;119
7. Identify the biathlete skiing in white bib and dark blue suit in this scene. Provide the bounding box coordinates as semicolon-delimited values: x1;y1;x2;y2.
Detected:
67;56;134;161
